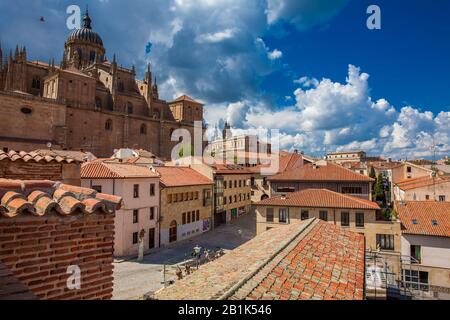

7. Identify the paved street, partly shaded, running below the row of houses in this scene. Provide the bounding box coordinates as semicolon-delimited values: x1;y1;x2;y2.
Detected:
113;214;256;300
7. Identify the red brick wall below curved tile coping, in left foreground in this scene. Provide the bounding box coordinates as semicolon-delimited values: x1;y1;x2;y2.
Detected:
0;214;114;300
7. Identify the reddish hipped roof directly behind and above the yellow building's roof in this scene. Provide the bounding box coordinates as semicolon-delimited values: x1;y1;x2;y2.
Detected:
269;162;374;182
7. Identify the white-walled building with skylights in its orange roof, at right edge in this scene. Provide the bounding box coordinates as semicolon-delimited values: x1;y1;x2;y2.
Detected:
395;201;450;300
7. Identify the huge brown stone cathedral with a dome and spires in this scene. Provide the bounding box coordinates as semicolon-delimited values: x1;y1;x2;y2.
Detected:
0;10;205;159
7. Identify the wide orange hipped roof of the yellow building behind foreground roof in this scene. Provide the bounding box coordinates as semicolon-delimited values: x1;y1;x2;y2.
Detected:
254;189;380;210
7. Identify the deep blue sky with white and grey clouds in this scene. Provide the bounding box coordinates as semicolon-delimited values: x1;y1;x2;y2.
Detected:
0;0;450;159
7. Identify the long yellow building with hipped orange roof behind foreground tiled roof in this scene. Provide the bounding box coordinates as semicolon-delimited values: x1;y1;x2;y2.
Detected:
255;189;401;254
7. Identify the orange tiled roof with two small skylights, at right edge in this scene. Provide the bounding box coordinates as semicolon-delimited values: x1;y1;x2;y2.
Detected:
395;201;450;237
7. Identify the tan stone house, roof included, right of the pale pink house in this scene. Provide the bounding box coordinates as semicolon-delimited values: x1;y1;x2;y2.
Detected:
155;167;213;246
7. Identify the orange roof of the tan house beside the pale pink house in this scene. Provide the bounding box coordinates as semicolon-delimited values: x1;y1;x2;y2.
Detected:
155;167;214;187
